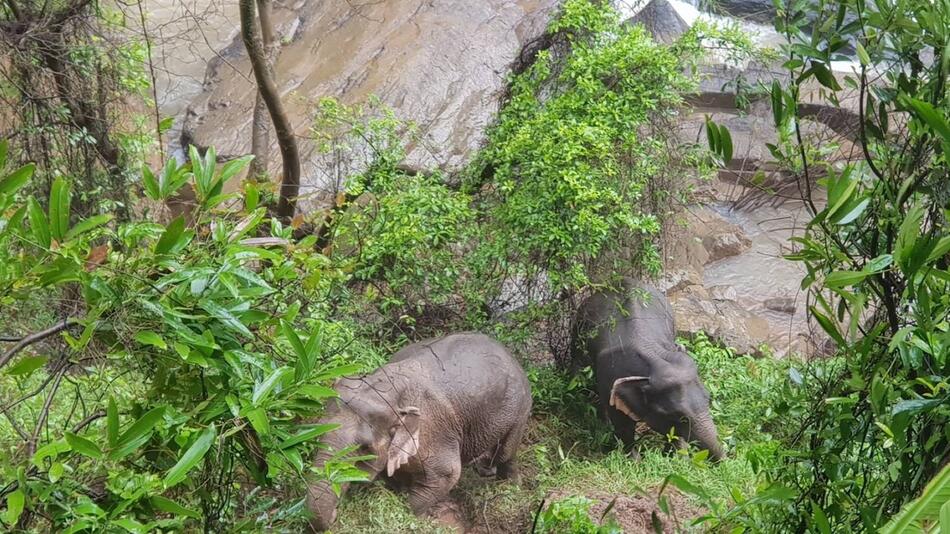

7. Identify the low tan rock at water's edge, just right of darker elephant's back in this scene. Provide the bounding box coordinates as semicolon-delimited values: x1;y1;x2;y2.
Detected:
670;293;771;355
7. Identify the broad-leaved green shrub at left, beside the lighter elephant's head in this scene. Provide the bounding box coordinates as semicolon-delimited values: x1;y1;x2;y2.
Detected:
0;146;378;531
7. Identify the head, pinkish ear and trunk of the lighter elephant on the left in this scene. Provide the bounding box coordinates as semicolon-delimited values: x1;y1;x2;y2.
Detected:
307;388;424;532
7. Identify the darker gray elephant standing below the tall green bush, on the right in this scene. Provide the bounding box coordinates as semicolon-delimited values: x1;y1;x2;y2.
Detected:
571;278;723;460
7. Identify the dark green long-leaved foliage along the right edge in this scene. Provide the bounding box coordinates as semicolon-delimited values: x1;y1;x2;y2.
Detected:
676;0;950;532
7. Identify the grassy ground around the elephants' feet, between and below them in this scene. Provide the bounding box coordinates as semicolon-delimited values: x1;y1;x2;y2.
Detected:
334;335;790;533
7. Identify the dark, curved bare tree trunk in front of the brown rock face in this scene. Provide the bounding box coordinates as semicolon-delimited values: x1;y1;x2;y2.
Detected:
239;0;300;222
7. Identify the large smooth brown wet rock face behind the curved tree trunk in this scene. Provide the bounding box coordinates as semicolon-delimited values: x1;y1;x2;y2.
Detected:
185;0;559;201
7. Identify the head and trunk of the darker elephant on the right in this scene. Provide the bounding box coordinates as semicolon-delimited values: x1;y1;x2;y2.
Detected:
609;347;723;460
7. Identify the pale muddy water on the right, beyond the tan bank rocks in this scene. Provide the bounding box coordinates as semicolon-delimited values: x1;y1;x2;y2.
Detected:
703;202;808;351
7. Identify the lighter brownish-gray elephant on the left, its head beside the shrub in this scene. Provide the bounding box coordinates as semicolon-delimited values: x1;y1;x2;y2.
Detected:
306;332;531;532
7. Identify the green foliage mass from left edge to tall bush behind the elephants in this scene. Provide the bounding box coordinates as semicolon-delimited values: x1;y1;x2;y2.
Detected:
0;1;716;532
